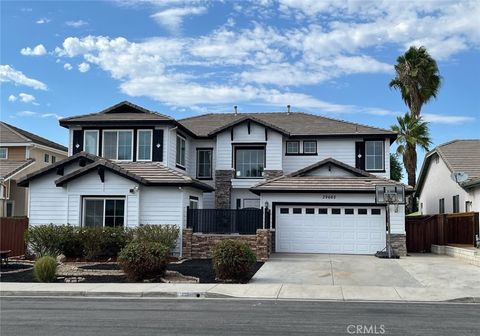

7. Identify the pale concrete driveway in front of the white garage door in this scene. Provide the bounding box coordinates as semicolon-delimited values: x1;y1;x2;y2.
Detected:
250;253;480;290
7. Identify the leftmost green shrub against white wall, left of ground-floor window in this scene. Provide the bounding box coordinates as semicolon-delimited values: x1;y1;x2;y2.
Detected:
25;224;76;258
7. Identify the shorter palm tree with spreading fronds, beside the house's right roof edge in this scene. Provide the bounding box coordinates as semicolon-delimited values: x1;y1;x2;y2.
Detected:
392;112;432;187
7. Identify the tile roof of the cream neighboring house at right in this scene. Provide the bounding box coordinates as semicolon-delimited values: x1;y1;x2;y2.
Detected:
417;139;480;193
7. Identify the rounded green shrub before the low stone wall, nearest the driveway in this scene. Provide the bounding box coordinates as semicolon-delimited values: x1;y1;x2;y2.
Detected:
212;240;257;282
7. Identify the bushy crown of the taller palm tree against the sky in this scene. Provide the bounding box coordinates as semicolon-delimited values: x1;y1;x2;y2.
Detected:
390;46;442;117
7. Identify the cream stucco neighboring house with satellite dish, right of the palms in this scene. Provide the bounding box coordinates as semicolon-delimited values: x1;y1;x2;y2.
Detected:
416;139;480;214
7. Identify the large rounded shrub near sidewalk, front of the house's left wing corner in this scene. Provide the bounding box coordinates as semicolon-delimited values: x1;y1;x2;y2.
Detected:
118;241;170;281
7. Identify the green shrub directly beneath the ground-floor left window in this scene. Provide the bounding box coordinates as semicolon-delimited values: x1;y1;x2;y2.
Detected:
80;227;132;260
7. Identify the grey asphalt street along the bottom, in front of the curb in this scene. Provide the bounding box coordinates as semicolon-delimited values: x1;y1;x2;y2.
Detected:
0;297;480;336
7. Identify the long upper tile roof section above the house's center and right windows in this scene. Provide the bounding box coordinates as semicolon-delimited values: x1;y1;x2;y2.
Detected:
178;112;396;137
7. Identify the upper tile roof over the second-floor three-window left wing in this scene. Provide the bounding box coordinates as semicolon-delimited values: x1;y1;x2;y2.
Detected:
60;101;174;126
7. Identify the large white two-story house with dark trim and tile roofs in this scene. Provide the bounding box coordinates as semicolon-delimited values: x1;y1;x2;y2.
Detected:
17;102;405;254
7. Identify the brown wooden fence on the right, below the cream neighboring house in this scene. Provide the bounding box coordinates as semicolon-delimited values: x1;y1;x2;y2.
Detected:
405;212;479;252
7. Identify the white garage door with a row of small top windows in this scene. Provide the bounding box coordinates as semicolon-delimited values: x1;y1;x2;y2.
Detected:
275;205;386;254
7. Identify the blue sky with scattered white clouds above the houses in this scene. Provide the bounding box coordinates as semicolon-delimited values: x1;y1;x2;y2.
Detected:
0;0;480;155
